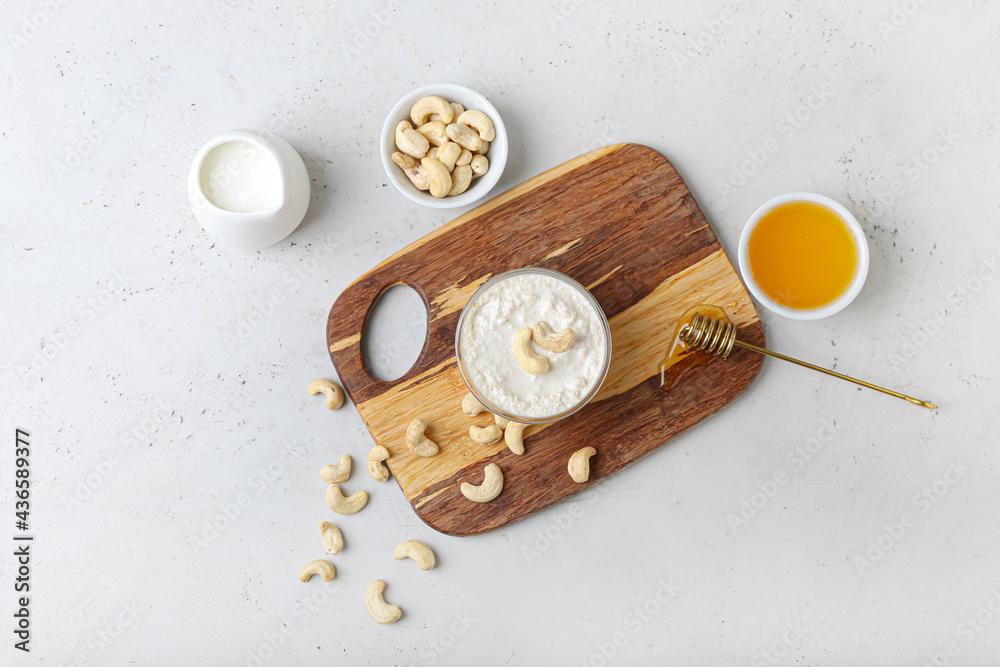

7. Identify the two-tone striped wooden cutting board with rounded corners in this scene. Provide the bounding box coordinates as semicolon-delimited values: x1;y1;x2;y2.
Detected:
327;144;764;535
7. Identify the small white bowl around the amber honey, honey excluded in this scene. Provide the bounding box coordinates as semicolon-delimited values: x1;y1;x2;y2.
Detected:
739;192;869;320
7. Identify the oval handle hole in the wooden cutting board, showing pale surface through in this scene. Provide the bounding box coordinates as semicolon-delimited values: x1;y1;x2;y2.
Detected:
361;284;427;382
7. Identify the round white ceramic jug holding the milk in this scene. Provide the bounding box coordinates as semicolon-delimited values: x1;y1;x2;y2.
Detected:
188;130;310;250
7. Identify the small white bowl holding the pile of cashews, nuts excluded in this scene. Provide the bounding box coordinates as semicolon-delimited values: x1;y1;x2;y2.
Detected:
379;83;507;208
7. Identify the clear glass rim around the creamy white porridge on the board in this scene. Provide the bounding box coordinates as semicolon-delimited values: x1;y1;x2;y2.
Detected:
455;268;611;424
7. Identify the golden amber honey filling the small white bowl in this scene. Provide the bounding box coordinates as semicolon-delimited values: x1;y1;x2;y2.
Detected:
747;201;858;310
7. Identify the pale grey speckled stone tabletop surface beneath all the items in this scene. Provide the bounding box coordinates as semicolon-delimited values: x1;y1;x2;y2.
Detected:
0;0;1000;667
